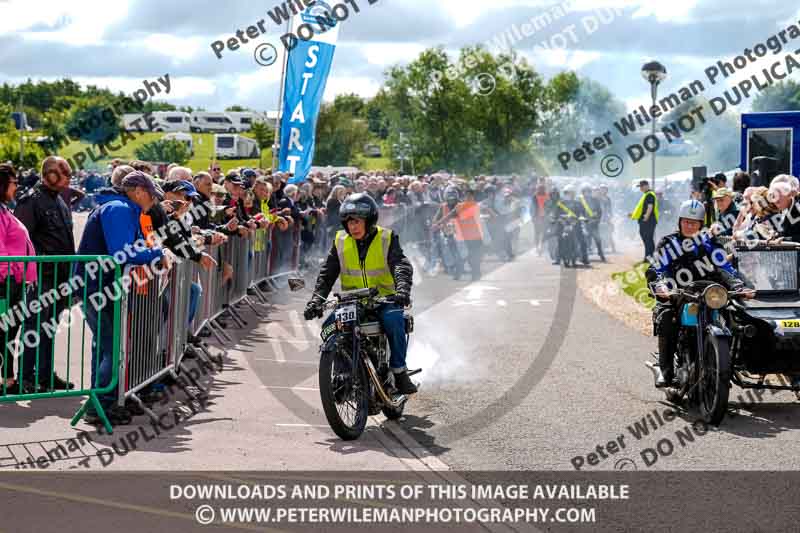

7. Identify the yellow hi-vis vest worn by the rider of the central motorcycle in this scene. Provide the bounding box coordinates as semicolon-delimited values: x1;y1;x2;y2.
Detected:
334;226;395;296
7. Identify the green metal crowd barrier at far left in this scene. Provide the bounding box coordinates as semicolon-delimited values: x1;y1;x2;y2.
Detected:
0;255;124;433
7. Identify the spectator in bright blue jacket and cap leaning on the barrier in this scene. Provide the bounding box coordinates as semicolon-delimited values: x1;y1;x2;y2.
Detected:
76;171;172;425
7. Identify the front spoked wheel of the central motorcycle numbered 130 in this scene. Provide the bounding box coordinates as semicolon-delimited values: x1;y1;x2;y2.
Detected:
319;350;369;440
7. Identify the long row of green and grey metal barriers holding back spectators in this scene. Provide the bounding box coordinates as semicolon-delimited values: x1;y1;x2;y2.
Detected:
0;216;346;433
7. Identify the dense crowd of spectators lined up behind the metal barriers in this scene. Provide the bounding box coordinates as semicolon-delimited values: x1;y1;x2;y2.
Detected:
0;157;560;425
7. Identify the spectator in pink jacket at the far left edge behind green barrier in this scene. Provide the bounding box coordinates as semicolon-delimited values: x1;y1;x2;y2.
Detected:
0;164;36;390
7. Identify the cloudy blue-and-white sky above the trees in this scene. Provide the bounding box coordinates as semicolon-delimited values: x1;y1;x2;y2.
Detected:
0;0;800;110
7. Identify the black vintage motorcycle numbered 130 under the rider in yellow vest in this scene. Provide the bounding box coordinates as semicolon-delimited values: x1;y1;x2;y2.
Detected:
289;279;421;440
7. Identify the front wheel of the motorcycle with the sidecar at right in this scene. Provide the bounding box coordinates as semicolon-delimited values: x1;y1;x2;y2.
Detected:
698;338;731;426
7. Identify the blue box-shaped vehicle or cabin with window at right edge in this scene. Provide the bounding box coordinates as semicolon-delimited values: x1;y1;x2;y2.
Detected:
740;111;800;181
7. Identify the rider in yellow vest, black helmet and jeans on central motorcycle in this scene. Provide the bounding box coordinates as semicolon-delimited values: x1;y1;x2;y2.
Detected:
303;193;417;394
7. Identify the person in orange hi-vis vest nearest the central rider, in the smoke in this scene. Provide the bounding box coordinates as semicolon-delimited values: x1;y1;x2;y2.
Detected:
434;188;483;281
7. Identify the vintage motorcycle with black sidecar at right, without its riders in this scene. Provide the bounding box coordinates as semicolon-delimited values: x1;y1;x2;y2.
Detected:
647;238;800;425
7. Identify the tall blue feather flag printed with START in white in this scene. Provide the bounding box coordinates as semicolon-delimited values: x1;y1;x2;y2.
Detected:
280;1;341;183
